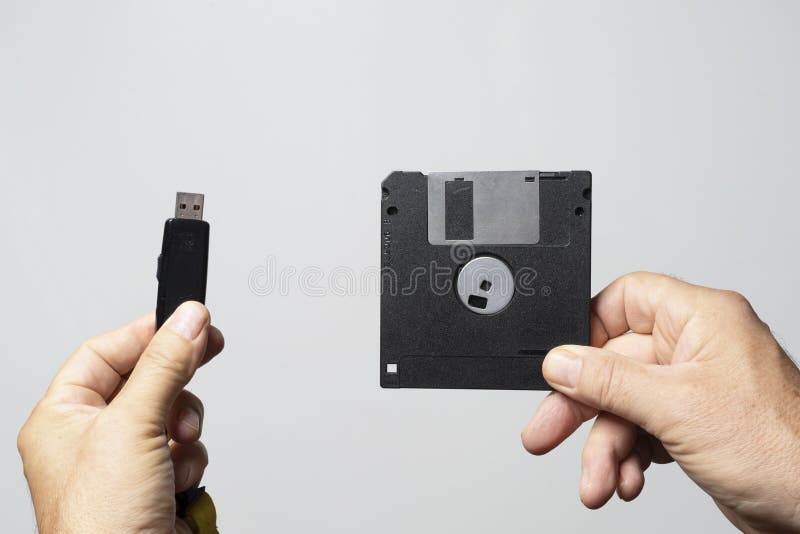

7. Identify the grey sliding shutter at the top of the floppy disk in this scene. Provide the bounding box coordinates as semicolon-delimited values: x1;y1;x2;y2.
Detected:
428;171;540;245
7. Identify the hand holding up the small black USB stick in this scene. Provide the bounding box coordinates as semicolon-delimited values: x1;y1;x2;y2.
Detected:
17;303;224;532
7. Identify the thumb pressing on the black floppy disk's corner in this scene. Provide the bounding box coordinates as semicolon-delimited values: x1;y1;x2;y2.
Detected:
542;345;670;428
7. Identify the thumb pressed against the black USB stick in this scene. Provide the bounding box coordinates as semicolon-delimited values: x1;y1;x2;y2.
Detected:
113;302;210;425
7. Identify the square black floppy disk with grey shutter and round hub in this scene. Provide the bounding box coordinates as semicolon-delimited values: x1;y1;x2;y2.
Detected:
380;171;592;389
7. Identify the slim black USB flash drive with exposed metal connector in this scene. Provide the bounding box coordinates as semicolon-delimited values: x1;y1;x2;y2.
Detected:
156;193;209;328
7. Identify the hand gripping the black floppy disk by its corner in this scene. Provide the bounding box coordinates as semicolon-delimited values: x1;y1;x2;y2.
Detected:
522;273;800;532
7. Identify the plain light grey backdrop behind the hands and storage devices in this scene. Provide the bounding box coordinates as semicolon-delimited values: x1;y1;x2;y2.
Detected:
0;0;800;533
